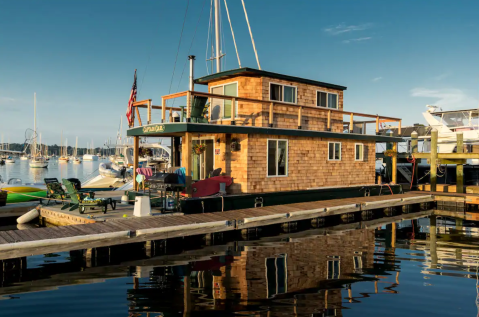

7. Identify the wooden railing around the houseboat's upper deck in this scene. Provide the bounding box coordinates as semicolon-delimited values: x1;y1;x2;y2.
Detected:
128;91;401;134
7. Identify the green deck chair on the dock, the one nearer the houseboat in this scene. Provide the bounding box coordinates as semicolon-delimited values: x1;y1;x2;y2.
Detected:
62;179;116;214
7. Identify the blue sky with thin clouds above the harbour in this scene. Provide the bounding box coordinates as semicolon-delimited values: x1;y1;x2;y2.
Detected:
0;0;479;146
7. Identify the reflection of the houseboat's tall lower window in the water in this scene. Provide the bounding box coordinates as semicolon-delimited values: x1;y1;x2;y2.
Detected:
266;254;288;298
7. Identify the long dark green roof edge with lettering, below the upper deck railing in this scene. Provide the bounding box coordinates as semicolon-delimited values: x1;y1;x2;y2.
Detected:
126;122;404;142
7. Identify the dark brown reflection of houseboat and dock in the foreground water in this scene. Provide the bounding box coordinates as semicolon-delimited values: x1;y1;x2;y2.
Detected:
0;211;479;316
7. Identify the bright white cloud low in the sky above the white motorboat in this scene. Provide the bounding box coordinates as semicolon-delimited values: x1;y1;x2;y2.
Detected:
411;87;478;110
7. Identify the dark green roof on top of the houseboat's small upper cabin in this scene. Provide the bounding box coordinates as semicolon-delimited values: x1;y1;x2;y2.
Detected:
195;67;347;90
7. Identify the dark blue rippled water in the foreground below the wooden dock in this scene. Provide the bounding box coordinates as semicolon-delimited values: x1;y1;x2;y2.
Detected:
0;211;479;317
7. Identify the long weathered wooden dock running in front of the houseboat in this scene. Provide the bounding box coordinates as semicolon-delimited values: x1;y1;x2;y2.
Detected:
0;192;434;259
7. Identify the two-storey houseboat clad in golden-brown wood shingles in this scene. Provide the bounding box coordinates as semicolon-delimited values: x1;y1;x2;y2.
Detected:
127;56;402;212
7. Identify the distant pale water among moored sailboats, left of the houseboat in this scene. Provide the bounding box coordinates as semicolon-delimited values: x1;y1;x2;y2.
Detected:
0;158;101;183
